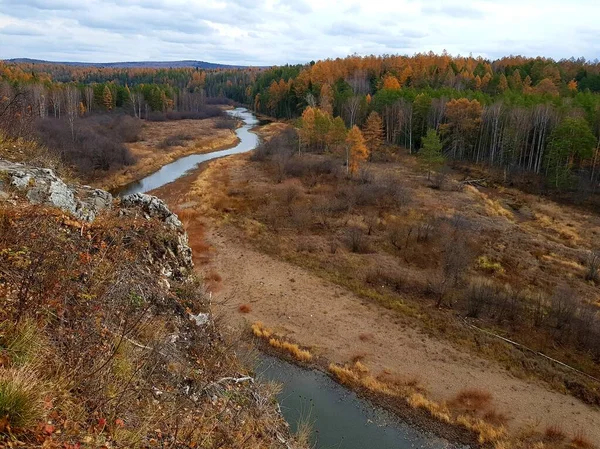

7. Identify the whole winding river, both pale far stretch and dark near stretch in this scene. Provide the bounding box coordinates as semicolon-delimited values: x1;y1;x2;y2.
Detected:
116;108;459;449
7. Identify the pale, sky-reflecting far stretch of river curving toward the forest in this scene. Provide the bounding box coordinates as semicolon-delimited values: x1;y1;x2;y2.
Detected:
115;108;258;196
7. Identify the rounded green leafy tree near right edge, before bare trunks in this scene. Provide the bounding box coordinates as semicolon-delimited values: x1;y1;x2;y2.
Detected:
546;117;596;188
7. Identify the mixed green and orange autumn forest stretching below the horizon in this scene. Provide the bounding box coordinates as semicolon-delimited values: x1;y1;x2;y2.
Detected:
0;53;600;195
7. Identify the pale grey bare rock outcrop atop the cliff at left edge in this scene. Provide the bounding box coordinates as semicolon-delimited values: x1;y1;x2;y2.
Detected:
0;160;112;221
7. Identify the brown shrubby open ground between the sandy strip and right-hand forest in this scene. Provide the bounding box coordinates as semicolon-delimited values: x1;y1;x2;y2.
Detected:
200;128;600;405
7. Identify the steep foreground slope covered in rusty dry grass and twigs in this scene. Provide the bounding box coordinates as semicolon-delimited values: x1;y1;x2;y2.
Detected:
0;204;298;448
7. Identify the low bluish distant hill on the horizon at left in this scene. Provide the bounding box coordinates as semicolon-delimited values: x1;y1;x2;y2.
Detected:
4;58;248;69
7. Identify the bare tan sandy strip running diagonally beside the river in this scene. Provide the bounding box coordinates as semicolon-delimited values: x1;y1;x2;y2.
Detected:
153;160;600;444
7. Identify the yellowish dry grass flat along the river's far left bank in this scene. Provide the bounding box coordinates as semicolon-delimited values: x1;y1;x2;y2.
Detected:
95;118;239;190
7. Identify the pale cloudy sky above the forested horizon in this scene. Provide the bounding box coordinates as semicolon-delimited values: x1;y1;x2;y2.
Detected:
0;0;600;65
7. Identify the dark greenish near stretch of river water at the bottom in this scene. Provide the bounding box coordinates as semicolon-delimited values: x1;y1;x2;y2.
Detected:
256;354;459;449
